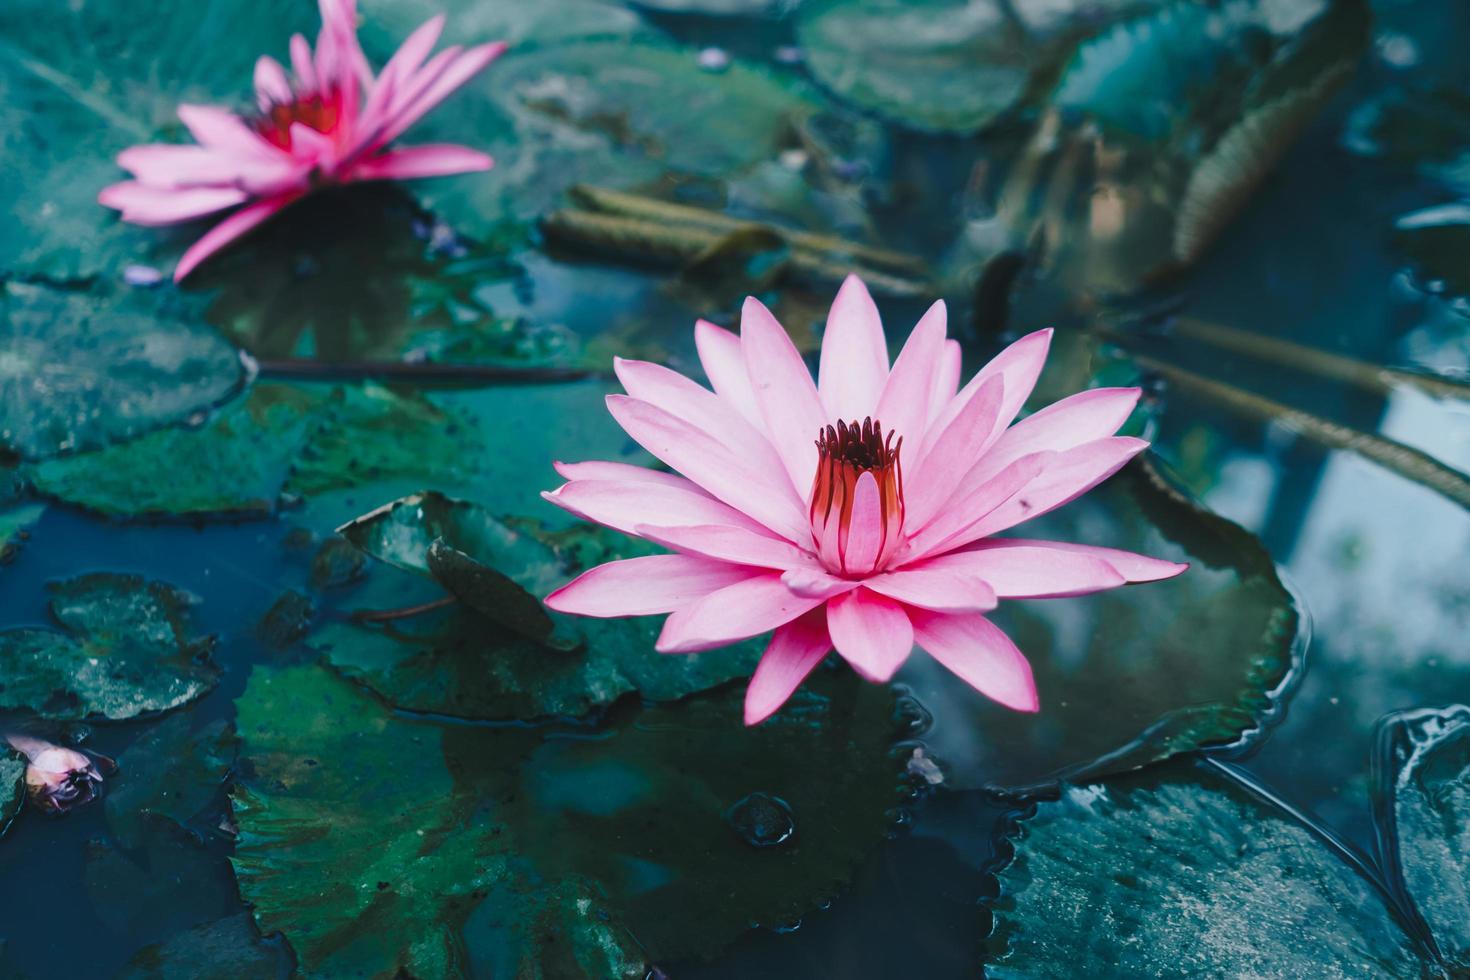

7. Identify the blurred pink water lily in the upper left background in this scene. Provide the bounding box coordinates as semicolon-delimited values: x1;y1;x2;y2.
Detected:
97;0;506;281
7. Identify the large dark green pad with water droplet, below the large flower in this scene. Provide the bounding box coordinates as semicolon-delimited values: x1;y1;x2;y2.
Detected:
234;667;898;977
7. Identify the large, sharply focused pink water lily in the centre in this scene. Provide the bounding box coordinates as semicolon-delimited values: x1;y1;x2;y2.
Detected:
545;276;1186;724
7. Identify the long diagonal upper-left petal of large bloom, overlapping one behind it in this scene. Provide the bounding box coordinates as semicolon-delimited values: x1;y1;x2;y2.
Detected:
607;395;810;541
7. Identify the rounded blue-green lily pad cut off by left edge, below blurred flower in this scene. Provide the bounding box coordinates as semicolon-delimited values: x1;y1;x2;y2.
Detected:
0;283;248;460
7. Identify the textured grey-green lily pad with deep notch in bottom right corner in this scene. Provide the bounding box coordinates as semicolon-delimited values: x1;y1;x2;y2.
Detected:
986;705;1470;977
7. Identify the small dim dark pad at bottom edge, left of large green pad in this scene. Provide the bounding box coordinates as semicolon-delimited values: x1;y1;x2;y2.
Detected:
121;912;291;980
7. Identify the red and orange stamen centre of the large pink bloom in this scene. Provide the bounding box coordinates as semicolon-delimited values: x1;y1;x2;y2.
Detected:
809;419;904;576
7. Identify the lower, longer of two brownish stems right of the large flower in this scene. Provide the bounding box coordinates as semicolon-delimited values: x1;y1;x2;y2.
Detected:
1133;354;1470;508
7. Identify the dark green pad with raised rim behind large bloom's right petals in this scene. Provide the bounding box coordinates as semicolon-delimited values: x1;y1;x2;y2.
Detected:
900;463;1299;792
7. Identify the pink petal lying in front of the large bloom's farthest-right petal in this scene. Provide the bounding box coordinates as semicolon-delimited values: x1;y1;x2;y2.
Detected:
908;541;1126;599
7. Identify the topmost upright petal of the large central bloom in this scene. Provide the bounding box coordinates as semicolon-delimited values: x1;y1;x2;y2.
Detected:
817;275;888;422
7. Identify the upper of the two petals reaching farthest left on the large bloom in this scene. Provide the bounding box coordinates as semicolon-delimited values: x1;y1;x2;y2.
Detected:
541;478;770;536
